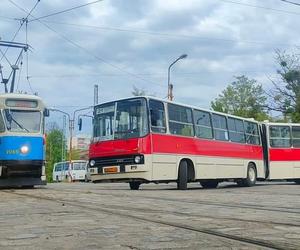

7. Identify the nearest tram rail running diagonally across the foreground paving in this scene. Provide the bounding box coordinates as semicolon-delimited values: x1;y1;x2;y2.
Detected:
0;191;297;250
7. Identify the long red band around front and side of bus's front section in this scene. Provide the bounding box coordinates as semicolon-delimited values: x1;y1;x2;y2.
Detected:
90;134;263;160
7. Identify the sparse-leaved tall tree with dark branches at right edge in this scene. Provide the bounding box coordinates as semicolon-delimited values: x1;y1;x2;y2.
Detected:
269;51;300;122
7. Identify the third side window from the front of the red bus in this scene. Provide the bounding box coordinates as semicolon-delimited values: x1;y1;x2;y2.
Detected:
194;110;213;139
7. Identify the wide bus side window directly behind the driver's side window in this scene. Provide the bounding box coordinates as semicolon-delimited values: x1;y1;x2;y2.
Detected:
168;104;194;136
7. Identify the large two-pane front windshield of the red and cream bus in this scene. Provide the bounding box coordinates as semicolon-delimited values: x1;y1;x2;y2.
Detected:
94;99;148;141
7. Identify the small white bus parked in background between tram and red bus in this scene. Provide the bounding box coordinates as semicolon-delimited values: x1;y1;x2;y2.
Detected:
52;160;90;182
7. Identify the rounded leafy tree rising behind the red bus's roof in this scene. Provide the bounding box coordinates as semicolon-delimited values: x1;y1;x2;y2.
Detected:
211;75;268;120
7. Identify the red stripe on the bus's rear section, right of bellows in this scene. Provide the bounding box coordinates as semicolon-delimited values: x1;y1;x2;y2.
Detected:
269;148;300;161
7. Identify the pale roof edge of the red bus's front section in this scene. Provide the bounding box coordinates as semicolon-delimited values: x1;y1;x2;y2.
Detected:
95;96;259;123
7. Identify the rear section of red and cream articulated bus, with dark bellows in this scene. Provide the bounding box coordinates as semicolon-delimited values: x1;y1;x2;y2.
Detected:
261;123;300;184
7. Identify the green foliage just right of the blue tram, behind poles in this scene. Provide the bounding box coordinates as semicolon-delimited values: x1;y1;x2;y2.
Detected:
46;128;66;182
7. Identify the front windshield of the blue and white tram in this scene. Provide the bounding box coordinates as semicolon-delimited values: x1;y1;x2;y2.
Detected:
4;109;41;133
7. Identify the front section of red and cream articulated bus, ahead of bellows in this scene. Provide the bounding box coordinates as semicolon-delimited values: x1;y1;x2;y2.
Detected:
89;97;264;189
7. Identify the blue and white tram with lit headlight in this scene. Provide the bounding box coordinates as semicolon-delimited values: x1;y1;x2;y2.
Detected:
0;94;49;187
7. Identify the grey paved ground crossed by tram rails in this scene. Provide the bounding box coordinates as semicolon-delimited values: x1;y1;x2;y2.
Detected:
0;182;300;250
